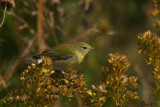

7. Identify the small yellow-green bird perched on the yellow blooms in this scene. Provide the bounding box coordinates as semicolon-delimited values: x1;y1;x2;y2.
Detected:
32;42;94;72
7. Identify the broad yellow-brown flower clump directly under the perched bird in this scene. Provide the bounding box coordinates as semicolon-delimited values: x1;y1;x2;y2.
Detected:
4;59;86;106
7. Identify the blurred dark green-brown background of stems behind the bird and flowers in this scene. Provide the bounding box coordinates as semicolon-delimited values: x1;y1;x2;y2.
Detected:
0;0;158;107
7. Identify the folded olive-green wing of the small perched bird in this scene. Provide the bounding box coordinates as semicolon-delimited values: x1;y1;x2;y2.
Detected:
42;44;75;60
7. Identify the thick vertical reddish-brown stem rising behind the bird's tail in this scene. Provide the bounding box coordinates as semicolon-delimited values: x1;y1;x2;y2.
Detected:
37;0;45;52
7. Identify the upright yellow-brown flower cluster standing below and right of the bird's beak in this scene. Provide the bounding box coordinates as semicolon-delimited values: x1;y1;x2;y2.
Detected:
101;54;139;107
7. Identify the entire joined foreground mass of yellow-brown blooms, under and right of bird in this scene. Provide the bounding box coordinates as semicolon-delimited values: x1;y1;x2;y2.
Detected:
4;54;139;107
